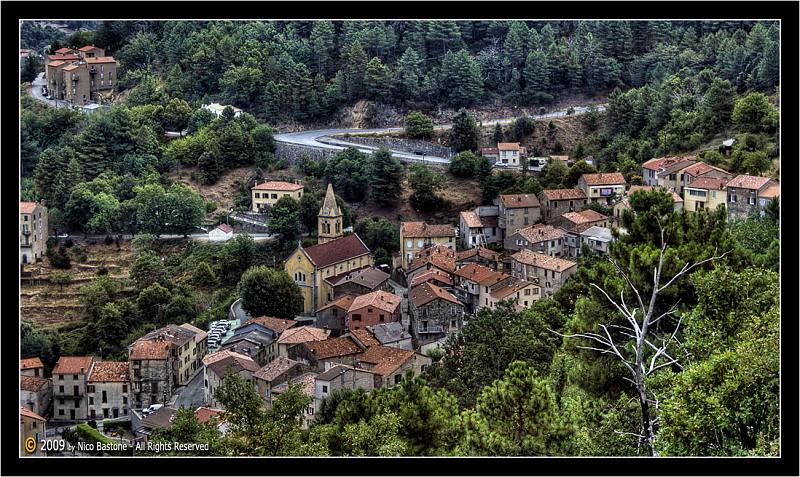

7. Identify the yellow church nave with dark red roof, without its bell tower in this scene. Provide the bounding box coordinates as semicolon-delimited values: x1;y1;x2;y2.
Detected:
283;234;375;316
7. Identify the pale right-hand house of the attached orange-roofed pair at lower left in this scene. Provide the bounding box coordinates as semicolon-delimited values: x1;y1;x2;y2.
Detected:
86;361;130;419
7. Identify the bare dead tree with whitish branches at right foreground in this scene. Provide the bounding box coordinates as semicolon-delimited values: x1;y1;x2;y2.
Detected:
550;222;730;456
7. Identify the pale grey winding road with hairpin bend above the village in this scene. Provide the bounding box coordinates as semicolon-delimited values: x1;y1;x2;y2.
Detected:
275;104;605;164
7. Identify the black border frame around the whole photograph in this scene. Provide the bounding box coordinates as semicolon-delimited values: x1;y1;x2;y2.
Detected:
0;1;800;475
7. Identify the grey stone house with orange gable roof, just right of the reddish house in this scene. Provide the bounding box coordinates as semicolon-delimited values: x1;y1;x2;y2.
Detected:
408;283;464;343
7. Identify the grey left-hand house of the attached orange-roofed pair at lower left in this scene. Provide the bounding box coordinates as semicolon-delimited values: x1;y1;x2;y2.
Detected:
52;356;95;422
